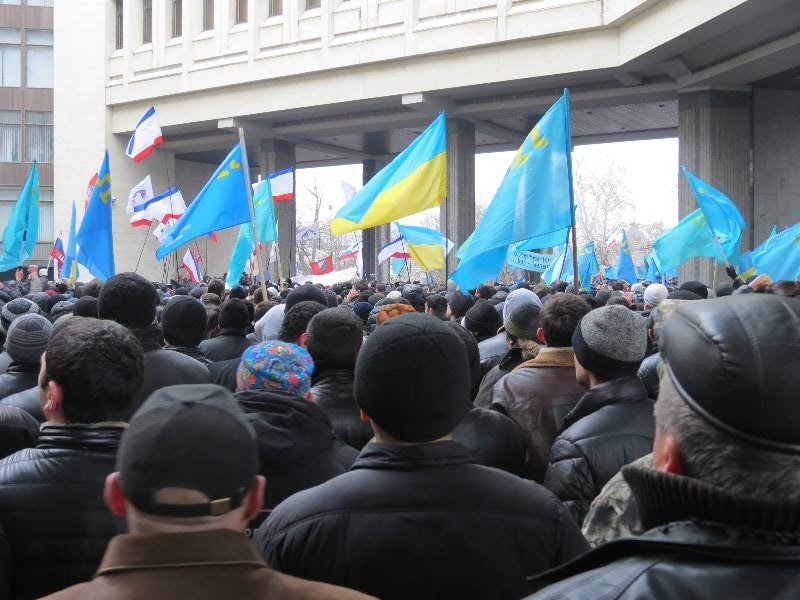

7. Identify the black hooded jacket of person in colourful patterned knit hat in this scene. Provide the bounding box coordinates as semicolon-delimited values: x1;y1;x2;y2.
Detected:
235;390;358;524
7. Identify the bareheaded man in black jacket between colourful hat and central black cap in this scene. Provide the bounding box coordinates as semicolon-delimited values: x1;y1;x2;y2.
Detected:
306;308;372;450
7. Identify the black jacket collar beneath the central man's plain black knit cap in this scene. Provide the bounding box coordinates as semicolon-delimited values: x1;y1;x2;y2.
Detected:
350;441;473;471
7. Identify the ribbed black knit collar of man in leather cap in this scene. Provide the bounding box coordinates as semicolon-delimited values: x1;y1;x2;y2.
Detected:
622;465;800;535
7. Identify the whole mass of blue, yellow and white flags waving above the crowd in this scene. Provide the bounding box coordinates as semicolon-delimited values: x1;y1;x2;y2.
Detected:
0;96;800;289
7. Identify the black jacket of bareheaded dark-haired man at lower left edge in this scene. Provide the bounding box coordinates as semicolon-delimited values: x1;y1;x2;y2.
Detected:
0;425;126;600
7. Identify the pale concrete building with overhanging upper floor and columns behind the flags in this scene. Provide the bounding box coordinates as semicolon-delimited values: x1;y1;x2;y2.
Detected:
53;0;800;282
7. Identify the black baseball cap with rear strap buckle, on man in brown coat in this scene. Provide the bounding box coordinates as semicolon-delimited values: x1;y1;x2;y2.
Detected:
117;384;258;518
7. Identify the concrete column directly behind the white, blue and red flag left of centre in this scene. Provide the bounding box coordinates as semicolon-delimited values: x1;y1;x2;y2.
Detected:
258;139;297;279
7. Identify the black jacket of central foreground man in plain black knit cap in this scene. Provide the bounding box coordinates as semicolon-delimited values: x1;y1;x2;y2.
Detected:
255;441;587;600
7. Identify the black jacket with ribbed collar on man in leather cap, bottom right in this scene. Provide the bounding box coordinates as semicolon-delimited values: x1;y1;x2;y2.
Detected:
531;465;800;600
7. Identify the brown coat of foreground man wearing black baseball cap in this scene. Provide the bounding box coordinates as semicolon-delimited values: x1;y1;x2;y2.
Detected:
45;529;378;600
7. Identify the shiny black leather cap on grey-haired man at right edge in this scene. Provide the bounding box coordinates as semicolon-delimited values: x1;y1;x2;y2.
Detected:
659;294;800;454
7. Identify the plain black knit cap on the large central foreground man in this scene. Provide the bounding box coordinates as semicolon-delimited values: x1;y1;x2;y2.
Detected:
355;313;470;442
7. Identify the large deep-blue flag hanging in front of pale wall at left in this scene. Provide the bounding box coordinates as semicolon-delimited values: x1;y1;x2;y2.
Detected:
75;155;116;281
